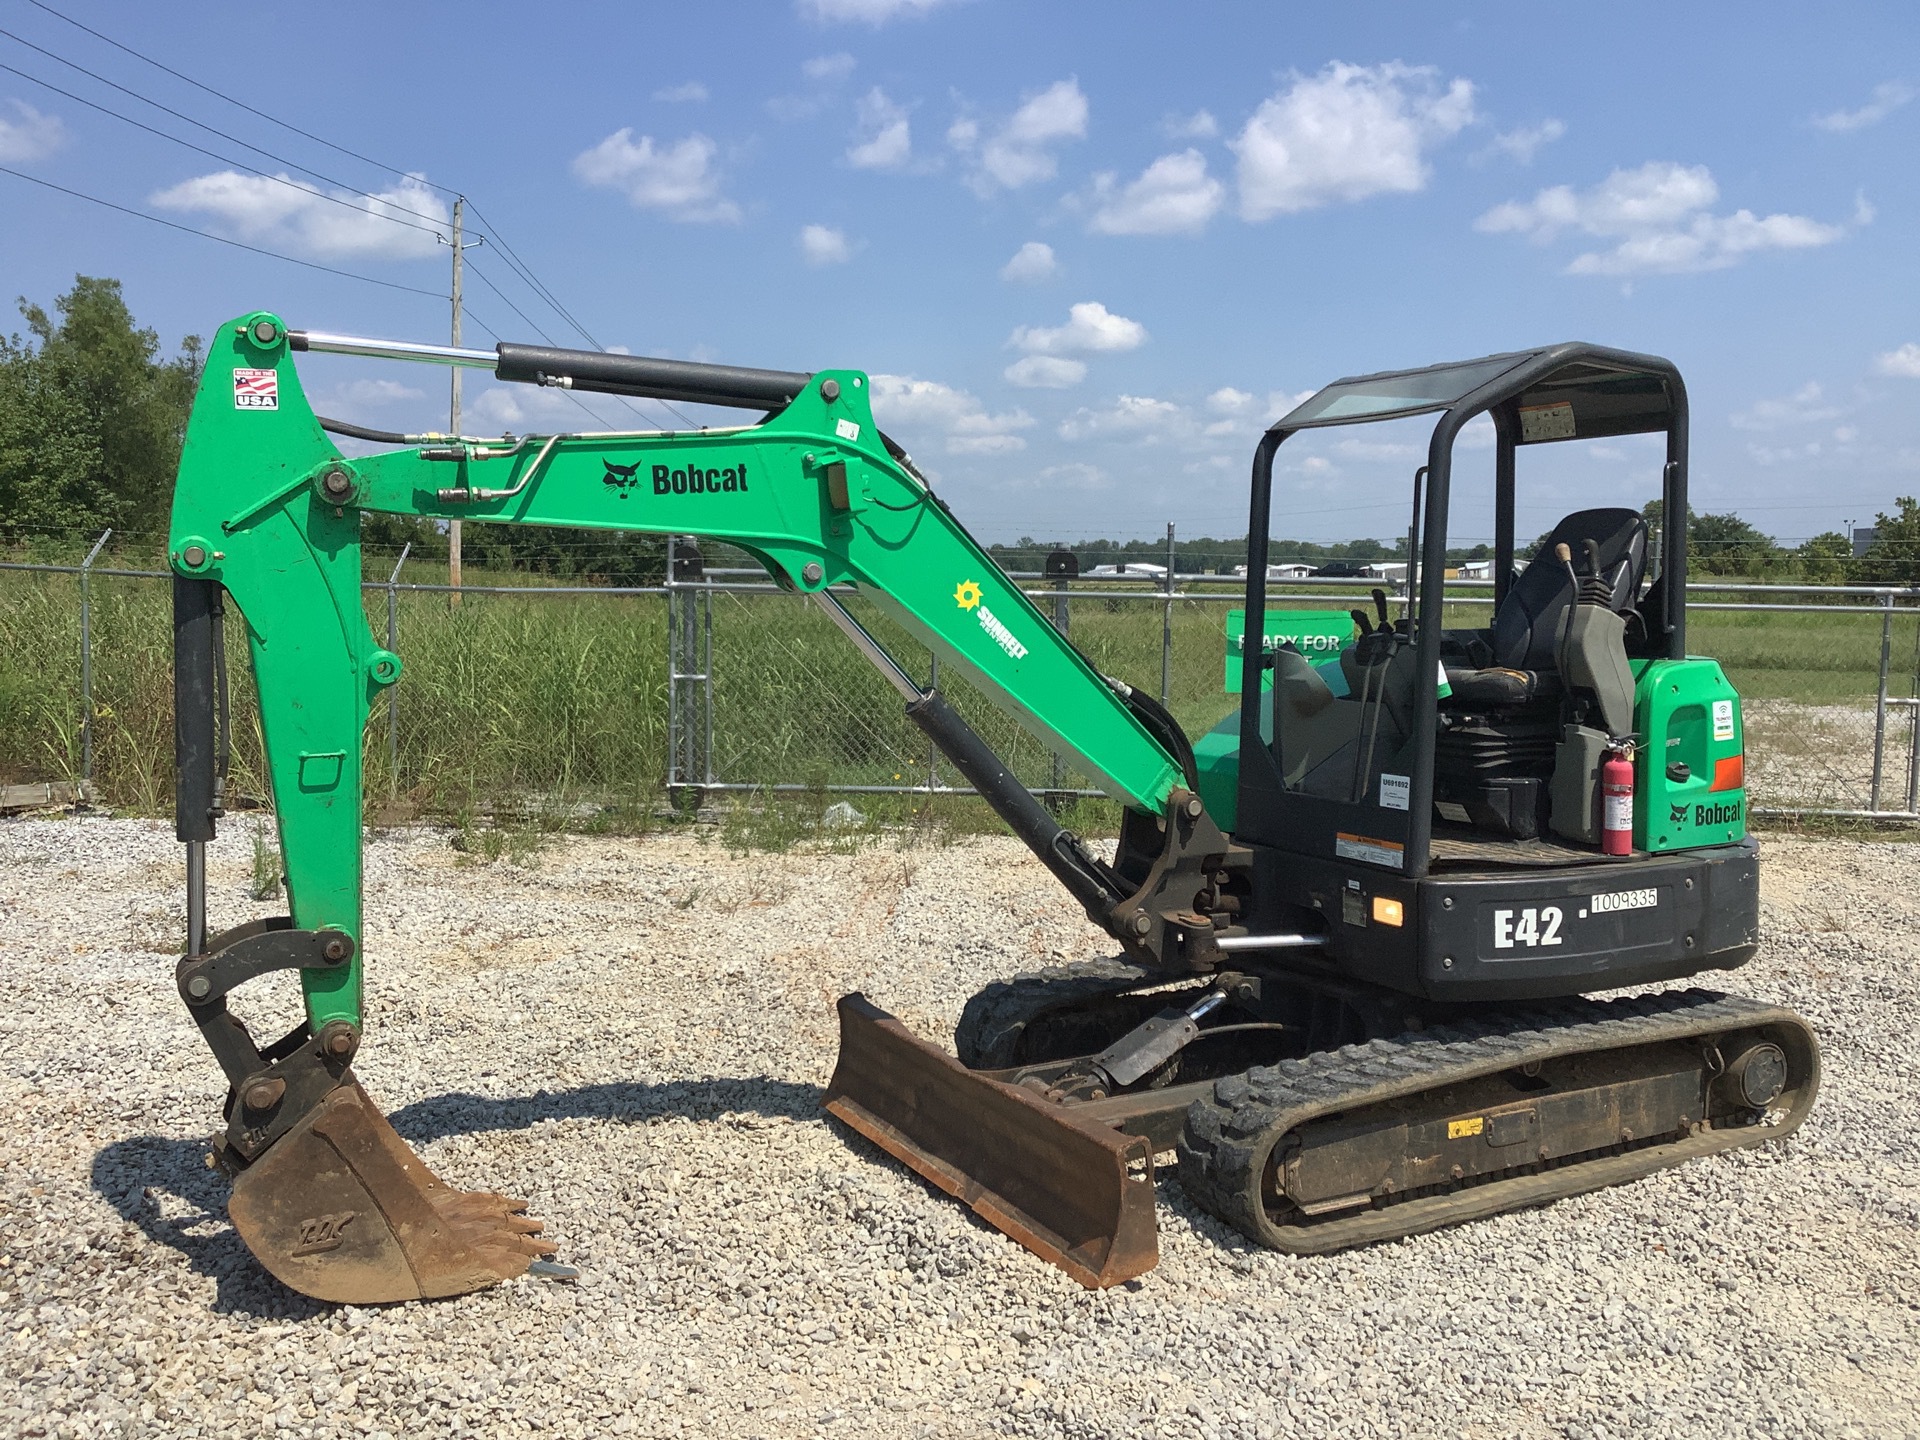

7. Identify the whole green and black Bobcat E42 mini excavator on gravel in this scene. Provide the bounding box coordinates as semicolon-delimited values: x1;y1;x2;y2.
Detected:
167;313;1818;1304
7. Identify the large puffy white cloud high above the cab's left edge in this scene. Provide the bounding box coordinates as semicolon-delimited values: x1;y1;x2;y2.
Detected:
1229;61;1475;221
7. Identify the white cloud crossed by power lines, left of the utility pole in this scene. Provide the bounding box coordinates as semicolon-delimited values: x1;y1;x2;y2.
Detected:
152;171;451;259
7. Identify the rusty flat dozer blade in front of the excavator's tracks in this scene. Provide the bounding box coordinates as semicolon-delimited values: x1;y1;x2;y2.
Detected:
826;995;1160;1288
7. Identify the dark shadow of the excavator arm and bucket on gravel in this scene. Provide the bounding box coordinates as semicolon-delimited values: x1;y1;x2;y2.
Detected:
92;1075;826;1321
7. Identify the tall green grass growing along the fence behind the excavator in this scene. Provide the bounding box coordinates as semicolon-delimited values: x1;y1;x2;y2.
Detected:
0;572;1916;840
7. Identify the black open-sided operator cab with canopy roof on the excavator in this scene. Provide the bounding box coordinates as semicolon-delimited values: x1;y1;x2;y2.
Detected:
1235;344;1688;879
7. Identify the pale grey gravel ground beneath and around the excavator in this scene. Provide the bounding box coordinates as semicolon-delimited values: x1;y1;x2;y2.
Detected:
0;820;1920;1436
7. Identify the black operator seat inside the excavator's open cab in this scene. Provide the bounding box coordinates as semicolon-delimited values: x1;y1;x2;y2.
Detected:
1446;509;1647;708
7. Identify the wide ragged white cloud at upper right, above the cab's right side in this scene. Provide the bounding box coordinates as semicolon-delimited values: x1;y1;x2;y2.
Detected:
1475;159;1872;275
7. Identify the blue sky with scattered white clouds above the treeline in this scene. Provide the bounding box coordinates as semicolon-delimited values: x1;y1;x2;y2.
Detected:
0;0;1920;540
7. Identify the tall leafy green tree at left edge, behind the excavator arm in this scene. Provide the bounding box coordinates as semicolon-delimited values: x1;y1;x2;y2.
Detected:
0;275;202;545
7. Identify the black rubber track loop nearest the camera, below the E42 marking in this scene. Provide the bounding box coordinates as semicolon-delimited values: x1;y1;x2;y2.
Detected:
1179;989;1820;1254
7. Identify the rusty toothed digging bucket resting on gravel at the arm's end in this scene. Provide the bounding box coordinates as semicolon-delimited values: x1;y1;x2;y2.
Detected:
227;1079;553;1306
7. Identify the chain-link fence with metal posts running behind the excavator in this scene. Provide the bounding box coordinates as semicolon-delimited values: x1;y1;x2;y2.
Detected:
0;538;1920;820
